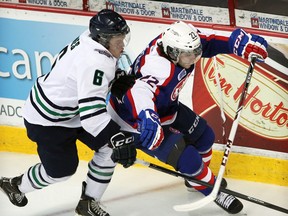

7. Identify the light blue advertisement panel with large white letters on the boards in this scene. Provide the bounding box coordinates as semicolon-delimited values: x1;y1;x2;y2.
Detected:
0;18;87;100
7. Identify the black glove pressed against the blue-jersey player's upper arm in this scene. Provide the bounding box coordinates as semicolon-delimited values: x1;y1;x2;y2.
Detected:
111;69;135;100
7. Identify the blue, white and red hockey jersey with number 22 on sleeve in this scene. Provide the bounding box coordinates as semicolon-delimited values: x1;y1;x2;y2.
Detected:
109;27;232;129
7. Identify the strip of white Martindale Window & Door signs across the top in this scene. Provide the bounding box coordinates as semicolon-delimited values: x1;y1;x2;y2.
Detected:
0;0;288;33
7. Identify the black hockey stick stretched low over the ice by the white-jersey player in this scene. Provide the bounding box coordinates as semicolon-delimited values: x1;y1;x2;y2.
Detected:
135;159;288;213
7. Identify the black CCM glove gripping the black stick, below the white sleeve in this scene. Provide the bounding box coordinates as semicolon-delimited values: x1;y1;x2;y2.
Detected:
110;131;137;168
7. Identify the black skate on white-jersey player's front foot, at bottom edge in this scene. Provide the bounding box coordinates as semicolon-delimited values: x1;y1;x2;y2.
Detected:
75;182;110;216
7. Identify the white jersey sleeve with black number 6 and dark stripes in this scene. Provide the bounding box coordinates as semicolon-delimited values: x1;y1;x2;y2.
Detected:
77;51;119;137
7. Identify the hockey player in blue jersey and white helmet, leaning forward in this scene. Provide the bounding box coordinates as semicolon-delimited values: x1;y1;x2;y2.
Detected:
108;21;267;214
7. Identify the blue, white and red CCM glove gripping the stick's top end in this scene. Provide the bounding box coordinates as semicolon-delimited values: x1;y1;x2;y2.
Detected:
229;29;268;62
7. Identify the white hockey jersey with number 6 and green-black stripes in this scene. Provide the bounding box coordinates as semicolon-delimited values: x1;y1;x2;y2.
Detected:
23;30;117;136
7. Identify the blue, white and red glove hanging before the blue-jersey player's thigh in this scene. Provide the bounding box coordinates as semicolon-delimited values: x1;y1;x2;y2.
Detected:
138;109;164;150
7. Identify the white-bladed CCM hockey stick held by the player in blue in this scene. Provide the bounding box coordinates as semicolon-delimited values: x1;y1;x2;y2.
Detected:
174;56;257;211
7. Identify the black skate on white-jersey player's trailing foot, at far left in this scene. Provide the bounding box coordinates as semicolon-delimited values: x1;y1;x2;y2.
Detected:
0;175;28;207
